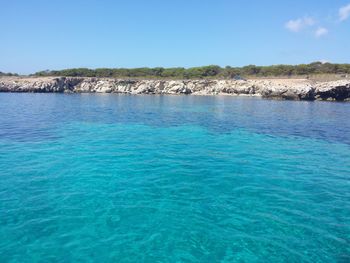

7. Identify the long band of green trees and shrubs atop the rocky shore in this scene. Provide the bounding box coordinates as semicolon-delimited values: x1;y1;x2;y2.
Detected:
30;62;350;79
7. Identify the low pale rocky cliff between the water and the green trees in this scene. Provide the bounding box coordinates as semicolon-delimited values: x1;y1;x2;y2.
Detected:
0;77;350;101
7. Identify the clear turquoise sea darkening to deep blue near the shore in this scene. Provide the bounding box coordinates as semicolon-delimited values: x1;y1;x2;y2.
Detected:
0;94;350;263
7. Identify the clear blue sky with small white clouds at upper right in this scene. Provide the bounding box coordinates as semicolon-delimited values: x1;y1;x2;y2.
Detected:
0;0;350;73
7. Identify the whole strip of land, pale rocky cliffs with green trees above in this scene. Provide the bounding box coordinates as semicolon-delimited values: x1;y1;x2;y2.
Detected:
0;62;350;101
